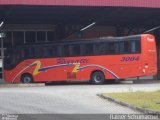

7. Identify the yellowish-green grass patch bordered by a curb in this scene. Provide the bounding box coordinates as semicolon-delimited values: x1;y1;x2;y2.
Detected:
103;90;160;111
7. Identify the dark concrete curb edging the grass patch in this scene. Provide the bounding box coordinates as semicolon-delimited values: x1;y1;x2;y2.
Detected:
97;94;160;117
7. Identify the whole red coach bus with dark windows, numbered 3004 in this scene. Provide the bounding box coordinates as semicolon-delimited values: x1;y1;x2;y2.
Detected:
4;34;157;84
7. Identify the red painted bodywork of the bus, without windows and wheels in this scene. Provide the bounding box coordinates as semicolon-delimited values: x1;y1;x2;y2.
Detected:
5;35;157;83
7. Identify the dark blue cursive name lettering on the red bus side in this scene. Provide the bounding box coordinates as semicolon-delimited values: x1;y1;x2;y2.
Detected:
57;58;88;64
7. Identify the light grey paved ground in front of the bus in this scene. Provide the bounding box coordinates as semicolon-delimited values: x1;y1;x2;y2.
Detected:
0;83;160;114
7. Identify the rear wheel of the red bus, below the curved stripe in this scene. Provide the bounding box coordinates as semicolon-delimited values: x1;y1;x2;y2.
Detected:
91;71;105;85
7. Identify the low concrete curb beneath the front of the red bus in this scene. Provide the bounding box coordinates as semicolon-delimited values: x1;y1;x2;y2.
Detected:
0;83;45;88
